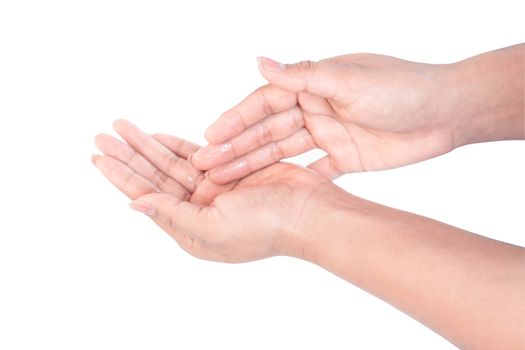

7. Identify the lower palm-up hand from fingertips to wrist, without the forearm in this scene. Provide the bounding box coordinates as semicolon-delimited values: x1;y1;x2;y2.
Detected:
93;120;346;262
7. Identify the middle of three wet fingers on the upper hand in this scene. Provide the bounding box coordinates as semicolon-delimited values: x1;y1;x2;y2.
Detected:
191;106;304;170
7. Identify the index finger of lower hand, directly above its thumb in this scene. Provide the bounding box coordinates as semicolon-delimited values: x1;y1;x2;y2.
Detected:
91;155;156;199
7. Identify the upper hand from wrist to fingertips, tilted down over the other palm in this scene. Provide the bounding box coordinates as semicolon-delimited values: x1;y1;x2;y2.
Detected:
192;54;464;183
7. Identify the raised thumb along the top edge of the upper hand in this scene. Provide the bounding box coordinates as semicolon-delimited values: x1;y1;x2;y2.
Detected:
257;57;344;98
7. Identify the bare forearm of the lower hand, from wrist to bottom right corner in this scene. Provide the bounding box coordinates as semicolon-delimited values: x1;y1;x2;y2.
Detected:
304;198;525;349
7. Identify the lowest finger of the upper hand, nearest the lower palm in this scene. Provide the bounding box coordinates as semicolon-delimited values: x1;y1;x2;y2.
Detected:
208;128;316;184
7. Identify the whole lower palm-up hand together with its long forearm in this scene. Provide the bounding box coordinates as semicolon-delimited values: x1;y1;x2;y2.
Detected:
93;120;525;349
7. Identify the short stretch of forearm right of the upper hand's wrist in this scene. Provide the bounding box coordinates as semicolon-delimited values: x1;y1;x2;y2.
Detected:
446;44;525;146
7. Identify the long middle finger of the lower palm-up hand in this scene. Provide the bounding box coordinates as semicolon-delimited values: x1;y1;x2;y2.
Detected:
95;134;189;198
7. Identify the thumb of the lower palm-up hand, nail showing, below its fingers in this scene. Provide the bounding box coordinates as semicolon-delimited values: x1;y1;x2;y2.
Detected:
129;193;204;238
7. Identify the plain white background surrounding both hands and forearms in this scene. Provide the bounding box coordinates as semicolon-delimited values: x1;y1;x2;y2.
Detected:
0;0;525;350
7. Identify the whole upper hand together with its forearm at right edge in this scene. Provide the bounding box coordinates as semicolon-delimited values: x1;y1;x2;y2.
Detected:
192;44;525;183
